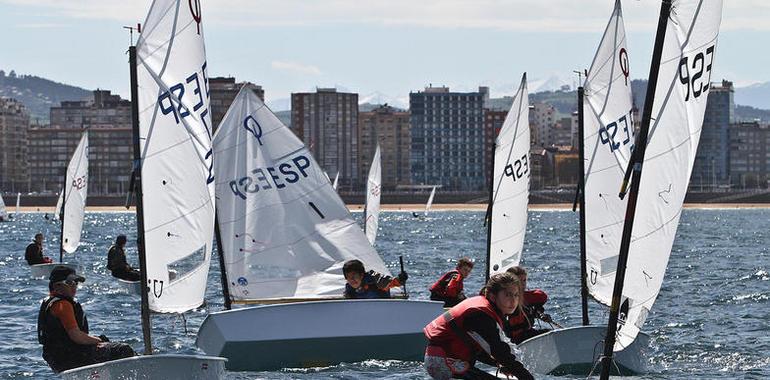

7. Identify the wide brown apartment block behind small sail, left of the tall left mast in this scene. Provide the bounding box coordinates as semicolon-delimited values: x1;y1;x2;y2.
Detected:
28;90;133;194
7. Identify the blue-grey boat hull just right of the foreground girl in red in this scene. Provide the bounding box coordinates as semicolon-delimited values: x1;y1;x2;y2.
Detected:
519;326;650;376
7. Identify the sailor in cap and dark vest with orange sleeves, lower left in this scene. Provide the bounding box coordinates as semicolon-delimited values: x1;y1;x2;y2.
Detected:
37;265;136;373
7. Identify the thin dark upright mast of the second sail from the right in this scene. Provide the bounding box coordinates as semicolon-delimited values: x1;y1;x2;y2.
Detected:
573;86;589;326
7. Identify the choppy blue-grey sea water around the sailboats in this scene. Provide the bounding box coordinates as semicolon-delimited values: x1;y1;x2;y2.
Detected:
0;209;770;379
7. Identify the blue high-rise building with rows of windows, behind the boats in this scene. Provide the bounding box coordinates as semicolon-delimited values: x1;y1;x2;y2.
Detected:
409;86;489;191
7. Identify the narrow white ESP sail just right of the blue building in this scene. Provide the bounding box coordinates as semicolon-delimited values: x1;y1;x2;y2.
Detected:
488;73;530;275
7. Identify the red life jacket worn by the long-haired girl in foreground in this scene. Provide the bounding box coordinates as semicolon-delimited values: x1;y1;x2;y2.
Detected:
423;296;504;363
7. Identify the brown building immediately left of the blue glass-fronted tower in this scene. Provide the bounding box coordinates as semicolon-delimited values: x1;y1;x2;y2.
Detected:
358;104;412;190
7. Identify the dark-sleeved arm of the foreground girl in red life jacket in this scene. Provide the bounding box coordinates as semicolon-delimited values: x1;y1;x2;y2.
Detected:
465;312;533;380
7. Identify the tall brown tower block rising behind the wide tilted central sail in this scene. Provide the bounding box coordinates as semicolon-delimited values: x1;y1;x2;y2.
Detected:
291;88;358;191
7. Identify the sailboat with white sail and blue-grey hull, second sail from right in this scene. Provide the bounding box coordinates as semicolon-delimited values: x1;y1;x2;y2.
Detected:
519;0;649;375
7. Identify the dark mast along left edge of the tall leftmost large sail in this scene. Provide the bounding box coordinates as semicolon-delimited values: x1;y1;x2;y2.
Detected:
128;46;152;355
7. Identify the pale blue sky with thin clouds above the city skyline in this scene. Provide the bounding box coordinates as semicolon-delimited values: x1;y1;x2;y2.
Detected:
0;0;770;108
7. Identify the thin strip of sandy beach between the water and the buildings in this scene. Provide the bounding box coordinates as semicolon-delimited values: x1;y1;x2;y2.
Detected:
16;203;770;214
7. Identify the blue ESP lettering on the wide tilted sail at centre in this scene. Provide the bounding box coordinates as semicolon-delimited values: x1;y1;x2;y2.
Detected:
228;154;311;200
